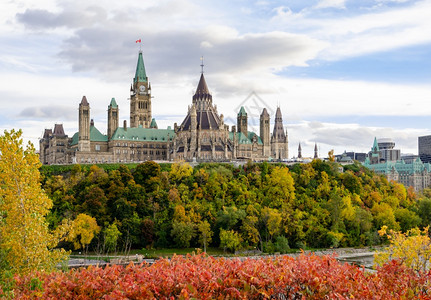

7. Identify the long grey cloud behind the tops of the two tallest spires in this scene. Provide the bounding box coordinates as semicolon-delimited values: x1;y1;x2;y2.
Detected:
56;27;323;82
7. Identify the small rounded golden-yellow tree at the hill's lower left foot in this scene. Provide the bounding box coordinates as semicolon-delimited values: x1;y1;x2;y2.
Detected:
67;214;100;250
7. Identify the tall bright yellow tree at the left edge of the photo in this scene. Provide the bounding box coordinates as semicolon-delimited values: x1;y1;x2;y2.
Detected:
0;130;67;273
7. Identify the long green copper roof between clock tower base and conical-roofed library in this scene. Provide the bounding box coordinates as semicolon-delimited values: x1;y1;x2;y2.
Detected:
111;127;175;142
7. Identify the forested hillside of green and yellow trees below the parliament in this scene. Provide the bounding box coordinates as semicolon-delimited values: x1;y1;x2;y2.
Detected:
41;160;431;252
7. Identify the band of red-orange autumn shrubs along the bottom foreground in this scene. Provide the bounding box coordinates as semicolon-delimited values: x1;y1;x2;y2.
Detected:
5;254;431;299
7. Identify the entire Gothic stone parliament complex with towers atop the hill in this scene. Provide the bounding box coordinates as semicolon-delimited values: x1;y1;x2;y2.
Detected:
39;51;289;165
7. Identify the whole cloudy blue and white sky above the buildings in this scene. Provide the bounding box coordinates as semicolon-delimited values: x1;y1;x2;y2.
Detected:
0;0;431;157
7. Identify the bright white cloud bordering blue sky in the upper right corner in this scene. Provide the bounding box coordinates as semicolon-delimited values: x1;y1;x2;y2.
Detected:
271;0;431;60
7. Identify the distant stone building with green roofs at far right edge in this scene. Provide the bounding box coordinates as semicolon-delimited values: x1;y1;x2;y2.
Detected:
363;139;431;192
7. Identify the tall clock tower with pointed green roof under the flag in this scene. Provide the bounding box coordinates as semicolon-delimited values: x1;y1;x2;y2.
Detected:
130;51;152;128
